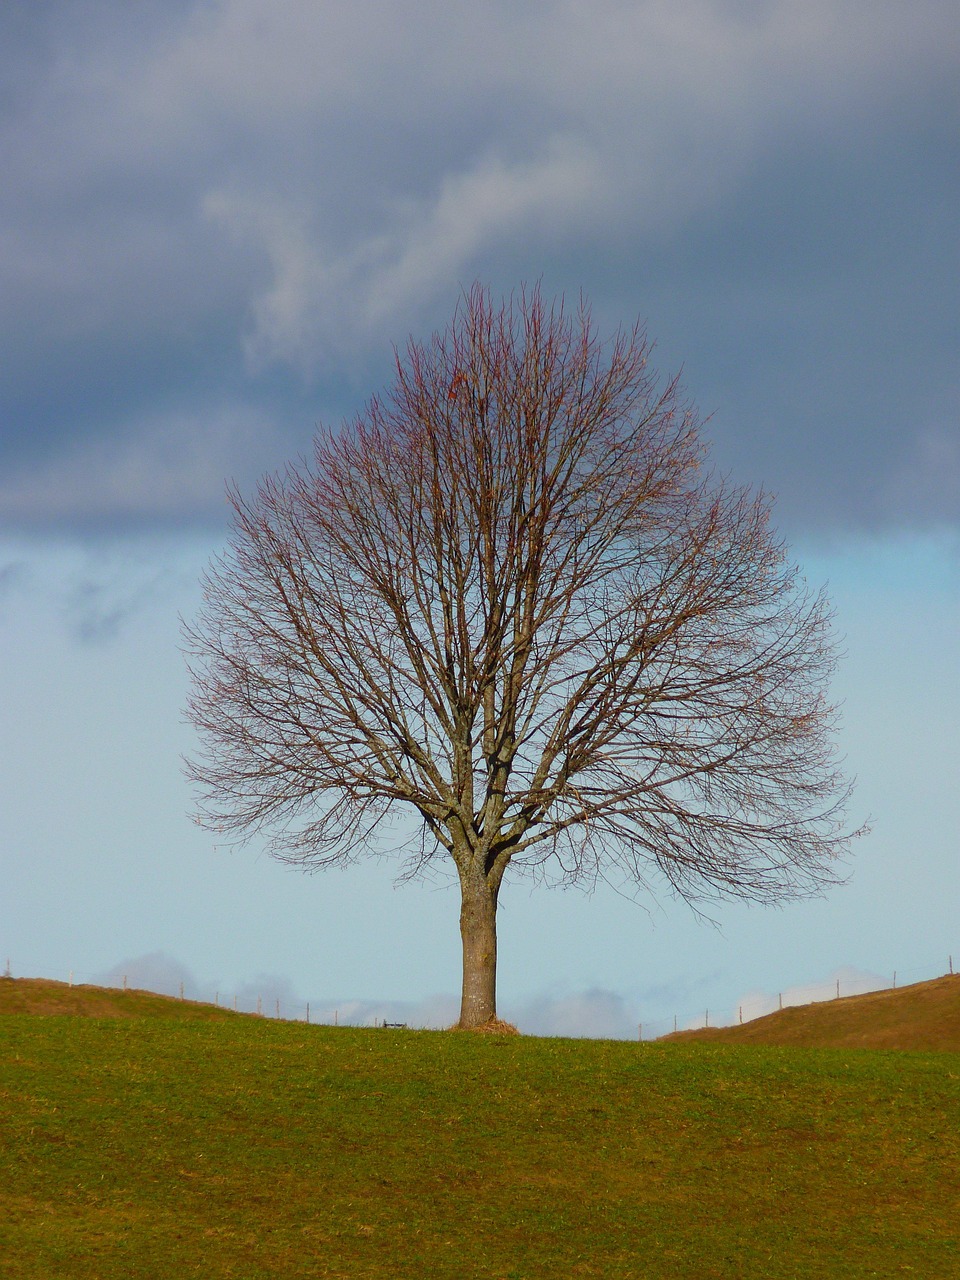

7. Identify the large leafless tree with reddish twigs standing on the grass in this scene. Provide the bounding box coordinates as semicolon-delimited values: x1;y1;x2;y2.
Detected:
187;287;851;1027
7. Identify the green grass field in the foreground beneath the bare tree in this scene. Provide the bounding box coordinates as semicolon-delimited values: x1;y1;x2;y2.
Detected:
0;983;960;1280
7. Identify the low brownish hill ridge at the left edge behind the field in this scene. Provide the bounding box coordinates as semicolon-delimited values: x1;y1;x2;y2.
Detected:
0;978;243;1020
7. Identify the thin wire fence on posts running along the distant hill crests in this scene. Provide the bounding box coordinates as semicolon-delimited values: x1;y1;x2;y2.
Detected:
3;954;960;1041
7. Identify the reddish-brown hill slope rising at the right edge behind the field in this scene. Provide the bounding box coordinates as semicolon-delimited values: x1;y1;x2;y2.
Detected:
660;974;960;1051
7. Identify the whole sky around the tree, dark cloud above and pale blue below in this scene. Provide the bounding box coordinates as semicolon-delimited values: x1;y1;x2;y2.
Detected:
0;0;960;1036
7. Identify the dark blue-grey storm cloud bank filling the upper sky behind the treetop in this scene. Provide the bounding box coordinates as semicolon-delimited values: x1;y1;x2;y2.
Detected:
0;0;960;529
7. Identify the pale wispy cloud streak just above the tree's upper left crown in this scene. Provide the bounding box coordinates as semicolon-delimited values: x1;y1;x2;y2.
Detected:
204;137;605;376
